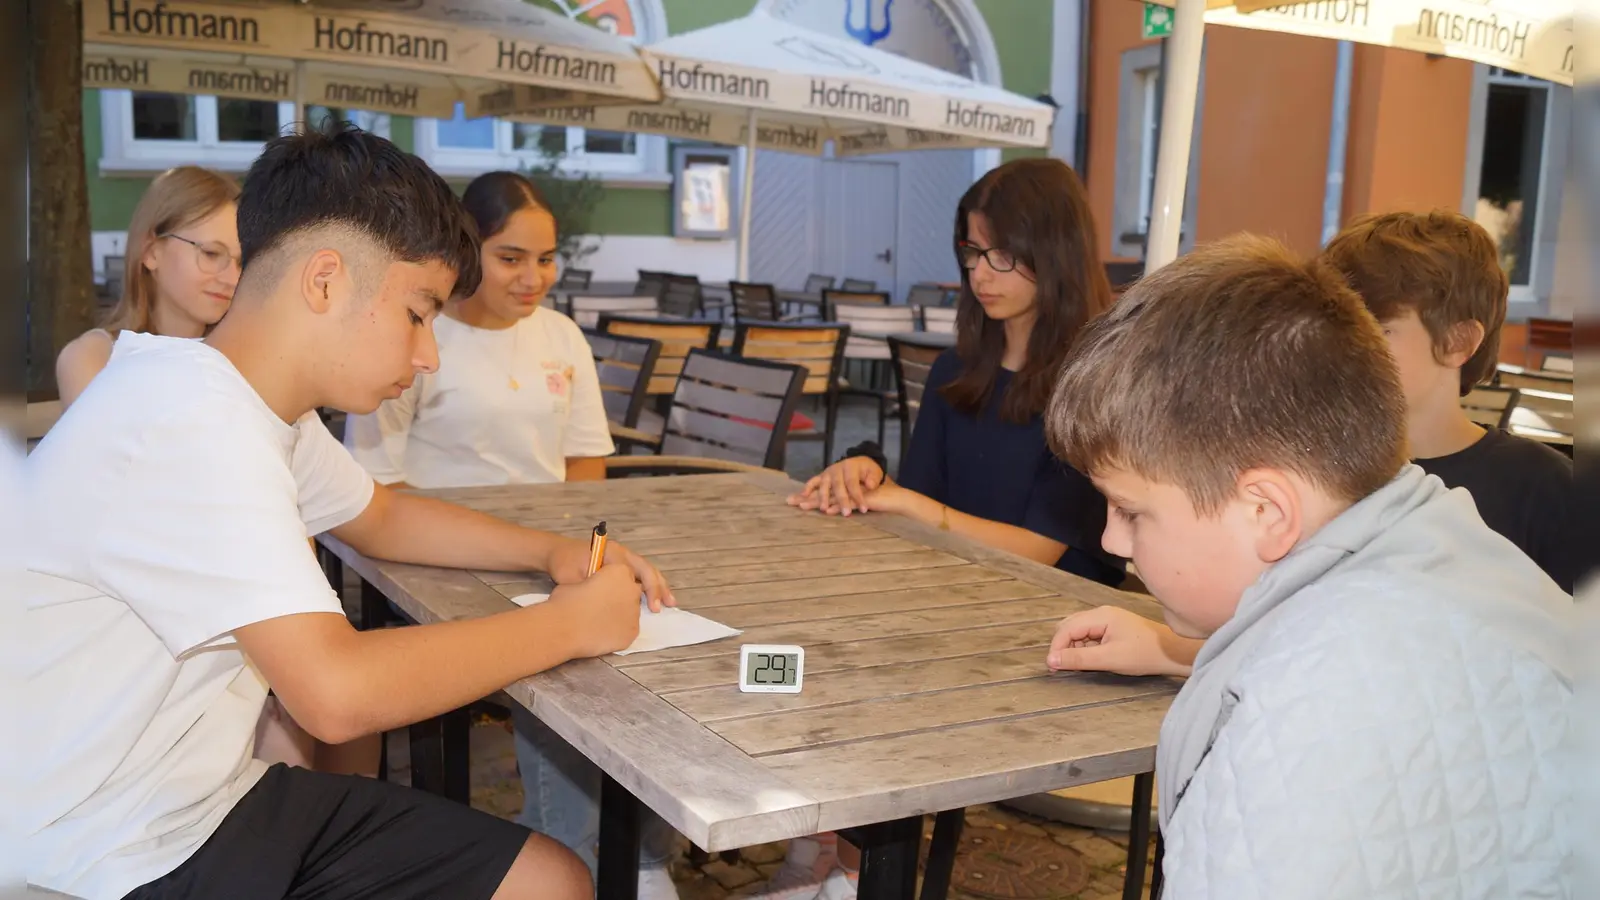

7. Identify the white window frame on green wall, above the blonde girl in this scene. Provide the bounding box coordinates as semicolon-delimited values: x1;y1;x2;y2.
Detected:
99;90;389;175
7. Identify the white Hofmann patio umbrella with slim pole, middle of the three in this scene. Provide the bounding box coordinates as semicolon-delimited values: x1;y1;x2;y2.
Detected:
499;10;1054;280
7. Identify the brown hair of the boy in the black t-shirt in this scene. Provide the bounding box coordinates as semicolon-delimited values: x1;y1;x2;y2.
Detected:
1323;210;1510;397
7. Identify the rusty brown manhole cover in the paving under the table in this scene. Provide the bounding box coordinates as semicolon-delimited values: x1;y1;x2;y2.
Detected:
923;826;1090;900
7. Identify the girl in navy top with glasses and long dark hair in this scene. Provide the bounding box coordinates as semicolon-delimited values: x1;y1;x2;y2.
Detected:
789;159;1125;586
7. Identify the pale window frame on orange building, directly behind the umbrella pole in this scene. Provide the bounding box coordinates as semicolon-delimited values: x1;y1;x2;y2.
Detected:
1110;43;1205;259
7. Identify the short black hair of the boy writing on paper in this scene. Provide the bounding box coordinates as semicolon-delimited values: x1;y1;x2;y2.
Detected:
238;120;482;296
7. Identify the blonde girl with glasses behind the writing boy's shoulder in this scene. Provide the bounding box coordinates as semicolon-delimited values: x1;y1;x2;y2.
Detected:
56;165;240;408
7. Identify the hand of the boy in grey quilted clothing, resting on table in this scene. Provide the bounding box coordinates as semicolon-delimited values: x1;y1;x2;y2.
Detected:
1046;607;1202;676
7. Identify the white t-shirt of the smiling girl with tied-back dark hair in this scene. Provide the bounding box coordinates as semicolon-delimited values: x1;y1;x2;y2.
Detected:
344;309;616;488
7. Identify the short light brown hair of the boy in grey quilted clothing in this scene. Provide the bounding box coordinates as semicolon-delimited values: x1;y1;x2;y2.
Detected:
1045;235;1406;516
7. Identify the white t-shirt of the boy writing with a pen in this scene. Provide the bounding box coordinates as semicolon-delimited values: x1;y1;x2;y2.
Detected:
18;331;373;898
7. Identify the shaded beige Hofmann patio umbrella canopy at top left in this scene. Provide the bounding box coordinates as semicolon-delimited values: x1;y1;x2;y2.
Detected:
83;0;659;119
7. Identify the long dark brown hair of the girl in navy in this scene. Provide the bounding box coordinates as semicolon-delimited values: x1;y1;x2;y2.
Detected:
944;159;1110;423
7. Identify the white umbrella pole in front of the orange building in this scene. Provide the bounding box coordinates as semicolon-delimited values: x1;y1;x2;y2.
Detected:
1144;0;1206;272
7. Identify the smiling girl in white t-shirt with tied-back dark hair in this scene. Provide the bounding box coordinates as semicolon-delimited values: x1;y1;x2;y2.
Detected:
344;171;677;900
